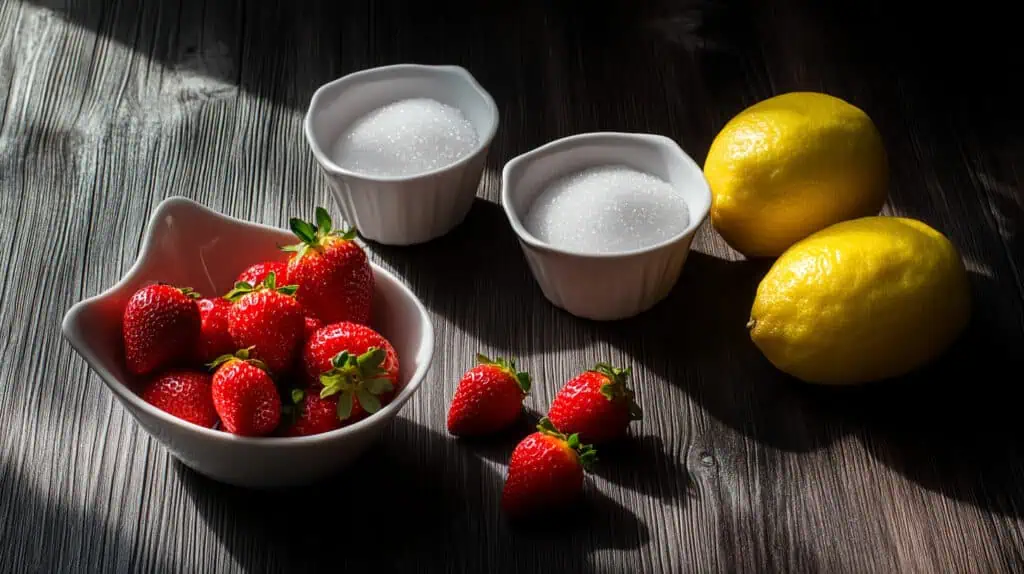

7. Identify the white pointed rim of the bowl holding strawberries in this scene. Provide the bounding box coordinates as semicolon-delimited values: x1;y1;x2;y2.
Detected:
60;196;434;448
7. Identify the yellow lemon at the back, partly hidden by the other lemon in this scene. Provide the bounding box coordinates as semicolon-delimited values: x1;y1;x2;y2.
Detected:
703;92;889;257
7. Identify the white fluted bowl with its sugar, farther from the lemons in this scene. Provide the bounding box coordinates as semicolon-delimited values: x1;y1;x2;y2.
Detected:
304;63;499;246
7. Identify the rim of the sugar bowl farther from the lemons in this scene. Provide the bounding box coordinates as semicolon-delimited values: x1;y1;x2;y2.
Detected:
302;63;501;183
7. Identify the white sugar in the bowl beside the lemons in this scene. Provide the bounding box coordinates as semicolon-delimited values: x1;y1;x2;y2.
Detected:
523;166;689;253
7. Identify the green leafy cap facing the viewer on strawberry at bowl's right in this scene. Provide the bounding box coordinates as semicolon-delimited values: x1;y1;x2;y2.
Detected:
319;347;394;421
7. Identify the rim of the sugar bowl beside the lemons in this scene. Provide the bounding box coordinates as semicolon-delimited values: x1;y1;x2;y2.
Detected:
501;131;712;260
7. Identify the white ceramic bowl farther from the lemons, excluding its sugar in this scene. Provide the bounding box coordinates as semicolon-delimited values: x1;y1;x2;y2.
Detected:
304;64;499;246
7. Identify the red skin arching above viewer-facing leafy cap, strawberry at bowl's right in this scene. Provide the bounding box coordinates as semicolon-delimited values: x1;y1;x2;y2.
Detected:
302;321;398;385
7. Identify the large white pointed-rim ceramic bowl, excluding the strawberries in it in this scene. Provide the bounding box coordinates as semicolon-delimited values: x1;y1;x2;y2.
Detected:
61;197;434;488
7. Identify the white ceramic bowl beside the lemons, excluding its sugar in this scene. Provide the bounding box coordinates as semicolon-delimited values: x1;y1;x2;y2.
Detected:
502;132;711;320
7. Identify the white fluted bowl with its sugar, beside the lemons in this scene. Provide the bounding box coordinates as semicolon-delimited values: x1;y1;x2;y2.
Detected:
502;132;711;320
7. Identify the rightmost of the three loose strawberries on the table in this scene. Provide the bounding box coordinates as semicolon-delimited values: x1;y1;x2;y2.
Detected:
548;363;642;444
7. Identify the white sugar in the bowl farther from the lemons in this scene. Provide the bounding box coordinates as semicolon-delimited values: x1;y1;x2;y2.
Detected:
333;98;478;176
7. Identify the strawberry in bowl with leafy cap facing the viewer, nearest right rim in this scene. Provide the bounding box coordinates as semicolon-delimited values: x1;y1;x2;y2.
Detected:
302;321;398;422
